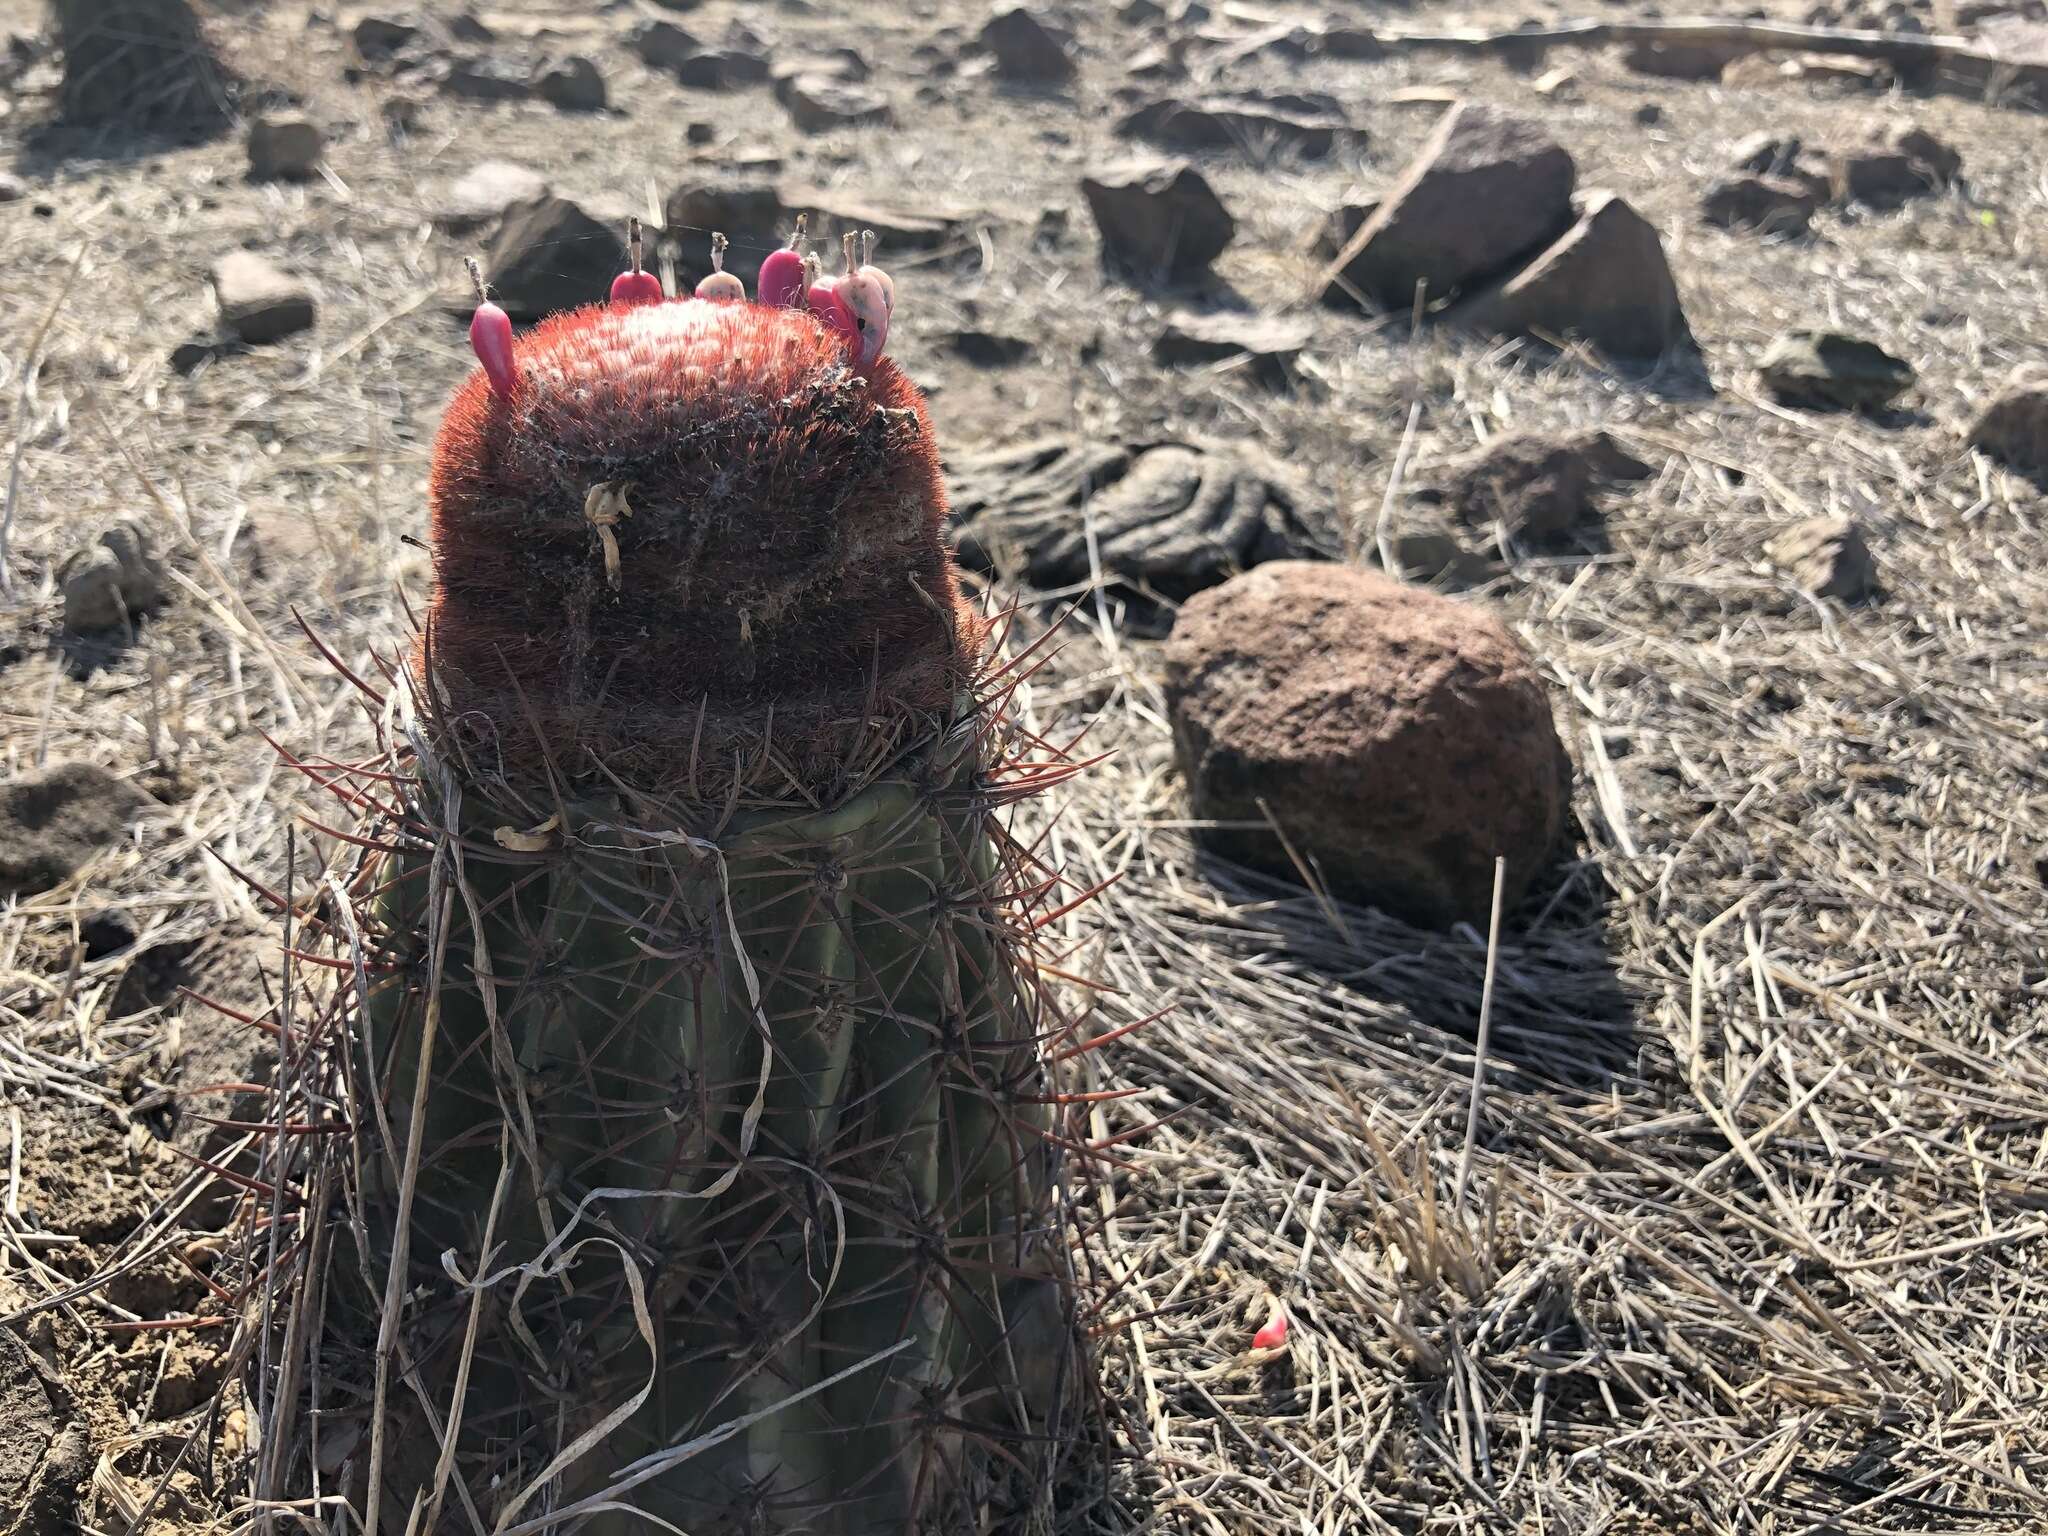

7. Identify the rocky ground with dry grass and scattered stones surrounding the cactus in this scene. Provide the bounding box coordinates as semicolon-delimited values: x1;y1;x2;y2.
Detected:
0;0;2048;1536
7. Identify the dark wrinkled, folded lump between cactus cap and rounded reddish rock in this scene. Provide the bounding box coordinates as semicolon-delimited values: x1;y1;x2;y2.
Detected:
948;436;1343;598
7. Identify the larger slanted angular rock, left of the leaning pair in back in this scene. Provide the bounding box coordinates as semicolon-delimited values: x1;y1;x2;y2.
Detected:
1321;104;1577;313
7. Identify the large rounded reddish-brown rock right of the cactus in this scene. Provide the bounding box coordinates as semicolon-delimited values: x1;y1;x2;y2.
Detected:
1163;561;1571;932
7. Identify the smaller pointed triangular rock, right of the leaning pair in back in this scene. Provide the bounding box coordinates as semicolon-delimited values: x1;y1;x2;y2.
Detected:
1458;193;1692;358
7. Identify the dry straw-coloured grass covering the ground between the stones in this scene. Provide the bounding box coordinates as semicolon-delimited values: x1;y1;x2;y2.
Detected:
0;6;2048;1536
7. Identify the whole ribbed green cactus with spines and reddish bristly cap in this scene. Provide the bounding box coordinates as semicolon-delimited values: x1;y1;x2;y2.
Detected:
301;299;1079;1536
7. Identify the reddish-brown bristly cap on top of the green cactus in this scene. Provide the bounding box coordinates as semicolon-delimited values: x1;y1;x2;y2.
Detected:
418;299;985;795
